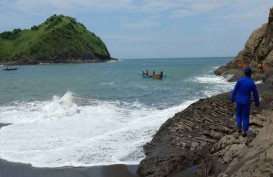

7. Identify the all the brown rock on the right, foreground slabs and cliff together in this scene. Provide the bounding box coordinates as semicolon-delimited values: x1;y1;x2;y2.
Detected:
138;6;273;177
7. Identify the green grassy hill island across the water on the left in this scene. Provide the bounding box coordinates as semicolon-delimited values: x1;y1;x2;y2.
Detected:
0;15;116;65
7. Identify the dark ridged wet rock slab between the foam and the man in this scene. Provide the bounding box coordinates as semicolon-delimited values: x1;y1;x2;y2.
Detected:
138;93;235;177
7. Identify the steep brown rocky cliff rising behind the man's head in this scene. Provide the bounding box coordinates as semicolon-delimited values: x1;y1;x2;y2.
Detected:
215;8;273;80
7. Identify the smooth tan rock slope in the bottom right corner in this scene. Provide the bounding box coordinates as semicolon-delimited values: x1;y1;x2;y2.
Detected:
218;110;273;177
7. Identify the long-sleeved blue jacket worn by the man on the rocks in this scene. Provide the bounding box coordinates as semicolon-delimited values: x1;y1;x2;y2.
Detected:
231;76;260;106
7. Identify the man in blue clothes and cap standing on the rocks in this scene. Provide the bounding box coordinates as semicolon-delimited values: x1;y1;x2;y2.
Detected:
231;67;260;137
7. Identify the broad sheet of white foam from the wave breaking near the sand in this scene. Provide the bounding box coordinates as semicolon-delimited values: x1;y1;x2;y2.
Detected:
0;92;195;167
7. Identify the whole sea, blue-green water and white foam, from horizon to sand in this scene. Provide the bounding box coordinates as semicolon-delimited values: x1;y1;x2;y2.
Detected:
0;57;234;167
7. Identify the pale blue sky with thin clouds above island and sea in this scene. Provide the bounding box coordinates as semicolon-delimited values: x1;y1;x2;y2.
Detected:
0;0;273;59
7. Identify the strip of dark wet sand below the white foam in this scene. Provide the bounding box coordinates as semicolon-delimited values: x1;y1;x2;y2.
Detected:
0;159;137;177
